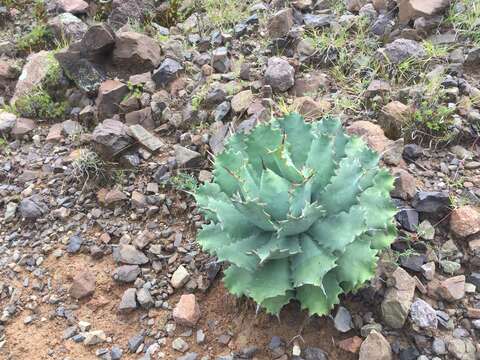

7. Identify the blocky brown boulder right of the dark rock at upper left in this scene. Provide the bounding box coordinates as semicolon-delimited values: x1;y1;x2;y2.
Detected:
113;31;161;74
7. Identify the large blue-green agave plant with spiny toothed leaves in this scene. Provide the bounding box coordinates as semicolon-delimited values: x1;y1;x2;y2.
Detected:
195;114;396;315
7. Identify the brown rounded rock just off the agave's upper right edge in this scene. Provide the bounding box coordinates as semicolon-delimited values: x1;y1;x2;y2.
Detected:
378;101;412;140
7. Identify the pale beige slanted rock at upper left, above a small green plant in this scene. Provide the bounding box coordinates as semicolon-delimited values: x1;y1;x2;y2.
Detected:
10;51;51;104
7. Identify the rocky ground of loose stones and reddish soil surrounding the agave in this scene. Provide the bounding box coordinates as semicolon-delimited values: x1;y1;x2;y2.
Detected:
0;0;480;360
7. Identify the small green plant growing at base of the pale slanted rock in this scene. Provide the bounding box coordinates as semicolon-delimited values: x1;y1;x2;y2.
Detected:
14;87;68;120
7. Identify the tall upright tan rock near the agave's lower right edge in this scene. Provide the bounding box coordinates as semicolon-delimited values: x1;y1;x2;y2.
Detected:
382;267;415;329
